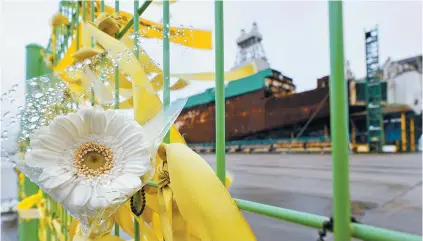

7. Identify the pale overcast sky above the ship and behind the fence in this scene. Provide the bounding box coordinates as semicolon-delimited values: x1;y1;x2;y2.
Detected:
1;0;422;91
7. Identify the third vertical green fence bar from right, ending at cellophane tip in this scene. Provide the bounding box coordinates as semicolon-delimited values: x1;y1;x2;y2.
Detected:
162;0;170;143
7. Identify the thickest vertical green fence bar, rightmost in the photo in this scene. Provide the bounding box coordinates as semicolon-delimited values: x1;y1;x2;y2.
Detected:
329;1;351;241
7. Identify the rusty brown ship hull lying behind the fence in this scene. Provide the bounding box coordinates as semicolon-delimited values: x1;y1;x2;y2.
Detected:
176;88;329;143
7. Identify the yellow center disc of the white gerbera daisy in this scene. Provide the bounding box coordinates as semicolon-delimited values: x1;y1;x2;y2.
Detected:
73;142;114;177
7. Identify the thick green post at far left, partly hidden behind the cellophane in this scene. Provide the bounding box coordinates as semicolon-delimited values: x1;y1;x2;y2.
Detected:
18;44;46;241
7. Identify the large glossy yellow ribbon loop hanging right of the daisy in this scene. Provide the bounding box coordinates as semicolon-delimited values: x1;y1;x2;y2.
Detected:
159;143;256;241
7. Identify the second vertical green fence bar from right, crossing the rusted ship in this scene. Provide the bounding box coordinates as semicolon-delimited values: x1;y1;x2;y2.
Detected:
214;0;226;184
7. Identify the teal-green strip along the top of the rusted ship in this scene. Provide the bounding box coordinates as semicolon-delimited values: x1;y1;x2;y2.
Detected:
185;69;272;108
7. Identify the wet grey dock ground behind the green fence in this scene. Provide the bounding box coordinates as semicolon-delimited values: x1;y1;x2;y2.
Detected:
2;153;422;241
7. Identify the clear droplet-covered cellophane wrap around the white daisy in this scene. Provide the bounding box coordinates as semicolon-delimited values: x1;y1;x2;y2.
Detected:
1;50;186;237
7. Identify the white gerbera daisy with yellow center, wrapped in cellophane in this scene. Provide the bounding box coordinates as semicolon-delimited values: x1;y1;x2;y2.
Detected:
25;107;152;217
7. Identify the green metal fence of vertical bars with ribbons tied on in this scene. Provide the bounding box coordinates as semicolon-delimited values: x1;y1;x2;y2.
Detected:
24;0;422;241
